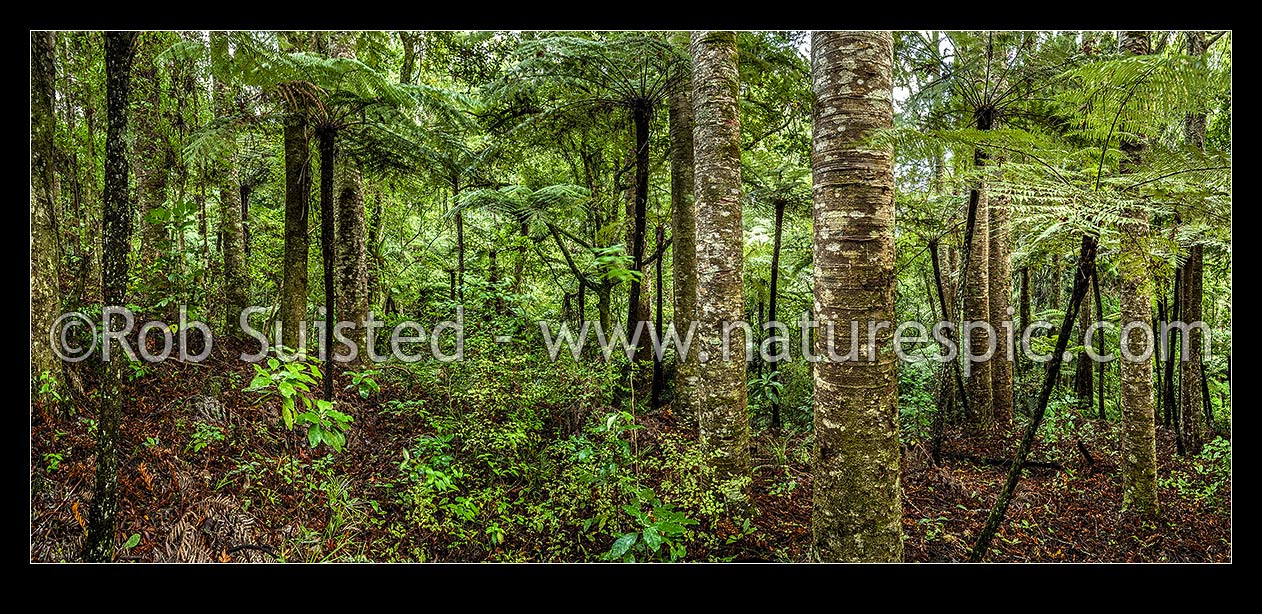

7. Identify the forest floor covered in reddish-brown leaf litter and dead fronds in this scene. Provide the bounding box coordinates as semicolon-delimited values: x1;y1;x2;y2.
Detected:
30;337;1232;562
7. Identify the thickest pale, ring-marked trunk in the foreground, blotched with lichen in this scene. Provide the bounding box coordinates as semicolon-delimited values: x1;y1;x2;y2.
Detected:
811;32;903;562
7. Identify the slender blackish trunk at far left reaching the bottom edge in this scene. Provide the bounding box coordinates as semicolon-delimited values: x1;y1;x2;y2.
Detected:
83;32;136;562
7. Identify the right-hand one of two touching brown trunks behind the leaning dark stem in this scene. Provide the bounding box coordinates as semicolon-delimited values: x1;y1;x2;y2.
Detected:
989;197;1016;426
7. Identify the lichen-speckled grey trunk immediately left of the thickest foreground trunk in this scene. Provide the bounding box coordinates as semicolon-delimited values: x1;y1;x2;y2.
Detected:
691;32;751;501
